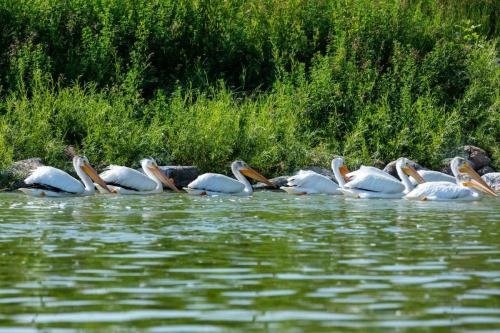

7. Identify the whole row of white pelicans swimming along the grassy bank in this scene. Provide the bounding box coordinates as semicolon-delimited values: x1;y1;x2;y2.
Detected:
19;156;497;201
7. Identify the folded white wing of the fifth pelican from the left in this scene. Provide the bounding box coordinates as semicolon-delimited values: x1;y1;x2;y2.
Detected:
345;167;405;193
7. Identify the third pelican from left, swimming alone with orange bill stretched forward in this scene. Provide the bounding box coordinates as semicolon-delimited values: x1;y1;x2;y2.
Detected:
184;161;275;196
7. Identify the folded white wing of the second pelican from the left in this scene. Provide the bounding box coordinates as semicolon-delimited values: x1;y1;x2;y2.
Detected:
99;165;156;191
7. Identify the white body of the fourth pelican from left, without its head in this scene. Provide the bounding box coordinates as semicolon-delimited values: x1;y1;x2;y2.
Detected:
281;164;342;195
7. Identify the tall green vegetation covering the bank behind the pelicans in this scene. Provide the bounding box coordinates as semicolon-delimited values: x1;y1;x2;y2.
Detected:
0;0;500;174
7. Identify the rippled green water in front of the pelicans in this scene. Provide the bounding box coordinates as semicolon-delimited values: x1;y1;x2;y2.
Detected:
0;193;500;333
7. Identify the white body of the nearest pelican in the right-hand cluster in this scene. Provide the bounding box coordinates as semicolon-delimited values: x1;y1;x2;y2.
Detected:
406;182;478;200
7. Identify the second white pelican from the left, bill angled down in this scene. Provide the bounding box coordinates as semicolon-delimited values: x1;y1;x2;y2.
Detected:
97;158;179;194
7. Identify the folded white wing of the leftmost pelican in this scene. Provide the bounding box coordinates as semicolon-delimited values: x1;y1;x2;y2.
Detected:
24;166;84;194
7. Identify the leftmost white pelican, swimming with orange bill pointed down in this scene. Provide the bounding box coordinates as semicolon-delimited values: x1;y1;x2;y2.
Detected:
19;156;110;197
